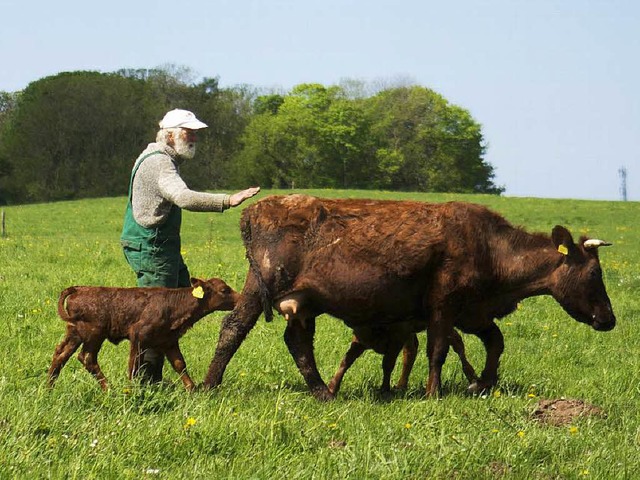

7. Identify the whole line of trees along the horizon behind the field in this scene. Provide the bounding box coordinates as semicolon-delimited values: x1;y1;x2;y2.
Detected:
0;67;504;203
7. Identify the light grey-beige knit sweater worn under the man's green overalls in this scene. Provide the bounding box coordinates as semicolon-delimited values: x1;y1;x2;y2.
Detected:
131;143;229;228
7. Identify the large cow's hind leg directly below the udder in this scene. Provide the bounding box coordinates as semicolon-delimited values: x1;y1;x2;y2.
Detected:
284;317;334;401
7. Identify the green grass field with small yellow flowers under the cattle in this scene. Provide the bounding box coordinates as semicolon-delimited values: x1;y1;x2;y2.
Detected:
0;191;640;479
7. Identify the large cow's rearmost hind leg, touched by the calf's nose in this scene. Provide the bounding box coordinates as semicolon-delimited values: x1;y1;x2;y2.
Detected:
203;270;262;388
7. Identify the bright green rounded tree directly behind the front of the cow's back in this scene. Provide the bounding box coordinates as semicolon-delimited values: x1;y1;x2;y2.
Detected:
232;84;372;188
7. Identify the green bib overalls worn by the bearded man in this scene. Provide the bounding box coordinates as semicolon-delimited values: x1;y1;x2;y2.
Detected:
120;151;191;287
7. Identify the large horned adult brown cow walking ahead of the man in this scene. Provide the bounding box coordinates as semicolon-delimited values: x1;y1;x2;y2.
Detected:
204;195;616;399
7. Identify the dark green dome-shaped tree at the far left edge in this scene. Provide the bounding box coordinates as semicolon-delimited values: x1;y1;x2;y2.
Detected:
0;72;156;201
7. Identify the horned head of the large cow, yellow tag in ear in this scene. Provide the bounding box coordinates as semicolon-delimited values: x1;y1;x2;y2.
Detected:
551;225;616;331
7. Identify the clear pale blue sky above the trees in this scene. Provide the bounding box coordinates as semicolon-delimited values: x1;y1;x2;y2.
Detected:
0;0;640;201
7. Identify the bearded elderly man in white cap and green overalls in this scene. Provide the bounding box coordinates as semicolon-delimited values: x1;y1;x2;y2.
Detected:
120;109;260;382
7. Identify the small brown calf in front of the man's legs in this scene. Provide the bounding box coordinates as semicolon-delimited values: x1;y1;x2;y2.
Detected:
48;278;239;390
